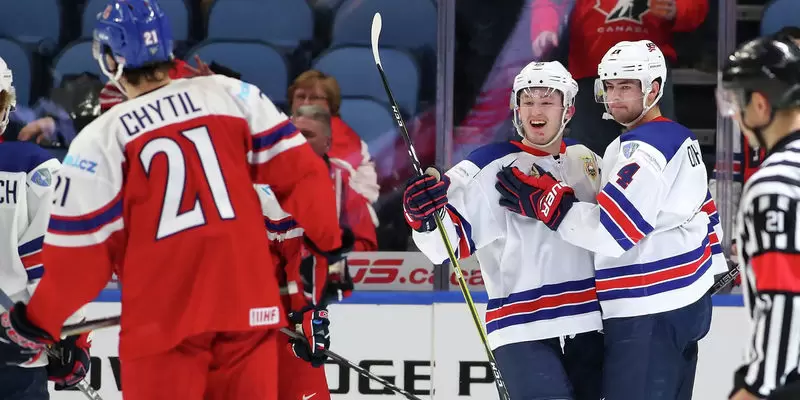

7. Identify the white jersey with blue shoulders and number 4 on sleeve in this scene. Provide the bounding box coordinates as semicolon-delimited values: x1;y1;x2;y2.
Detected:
558;118;727;319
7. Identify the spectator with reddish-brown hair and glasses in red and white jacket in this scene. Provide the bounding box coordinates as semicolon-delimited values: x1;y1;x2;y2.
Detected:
287;69;380;222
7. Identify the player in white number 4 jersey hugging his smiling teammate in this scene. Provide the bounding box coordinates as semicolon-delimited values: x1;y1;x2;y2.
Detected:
496;40;727;400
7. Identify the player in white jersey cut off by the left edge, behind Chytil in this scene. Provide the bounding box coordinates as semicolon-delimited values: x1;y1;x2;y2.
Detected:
0;58;89;400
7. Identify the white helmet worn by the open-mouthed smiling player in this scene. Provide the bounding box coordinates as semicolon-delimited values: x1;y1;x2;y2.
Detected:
511;61;578;148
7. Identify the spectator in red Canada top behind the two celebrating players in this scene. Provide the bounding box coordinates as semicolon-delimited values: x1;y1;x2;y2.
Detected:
531;0;708;154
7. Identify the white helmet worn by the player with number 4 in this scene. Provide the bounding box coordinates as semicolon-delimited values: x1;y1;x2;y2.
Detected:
594;40;667;127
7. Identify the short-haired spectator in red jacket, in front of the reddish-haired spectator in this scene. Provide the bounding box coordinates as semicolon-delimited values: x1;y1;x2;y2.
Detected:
292;105;378;251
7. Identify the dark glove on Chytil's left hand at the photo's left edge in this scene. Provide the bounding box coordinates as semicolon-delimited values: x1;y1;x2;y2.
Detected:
0;302;53;365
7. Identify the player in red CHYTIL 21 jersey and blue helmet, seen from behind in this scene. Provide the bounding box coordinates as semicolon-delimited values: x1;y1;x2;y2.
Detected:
0;0;345;400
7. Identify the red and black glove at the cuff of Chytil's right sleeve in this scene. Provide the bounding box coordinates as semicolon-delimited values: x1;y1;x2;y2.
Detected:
300;228;356;308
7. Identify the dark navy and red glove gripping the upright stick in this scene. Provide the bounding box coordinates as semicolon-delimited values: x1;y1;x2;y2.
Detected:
403;167;450;232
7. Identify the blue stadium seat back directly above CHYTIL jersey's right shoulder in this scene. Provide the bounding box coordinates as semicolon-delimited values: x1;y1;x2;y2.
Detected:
186;40;289;104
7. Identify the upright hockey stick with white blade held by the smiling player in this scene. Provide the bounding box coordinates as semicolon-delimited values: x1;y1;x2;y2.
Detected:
371;13;511;400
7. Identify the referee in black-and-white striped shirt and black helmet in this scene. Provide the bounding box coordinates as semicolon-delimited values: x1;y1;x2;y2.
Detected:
717;34;800;400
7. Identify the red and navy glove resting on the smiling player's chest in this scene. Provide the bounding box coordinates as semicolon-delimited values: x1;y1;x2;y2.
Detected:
495;164;576;230
